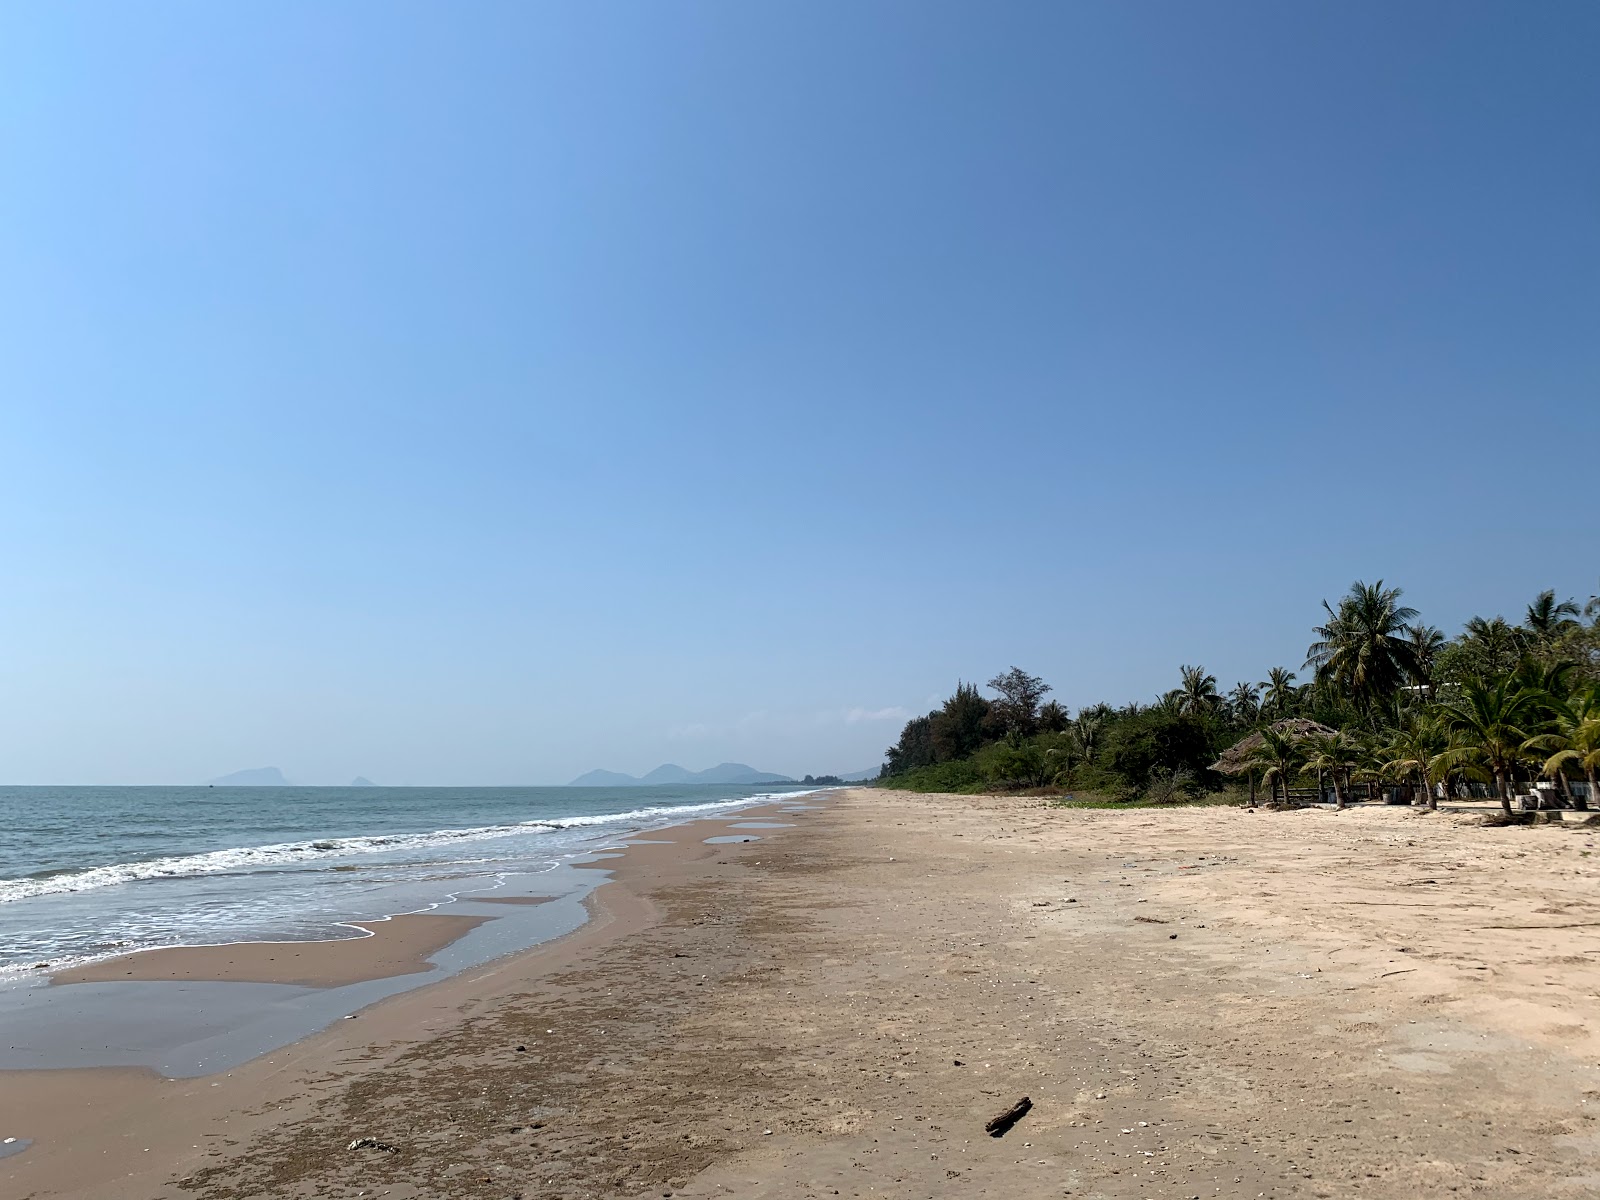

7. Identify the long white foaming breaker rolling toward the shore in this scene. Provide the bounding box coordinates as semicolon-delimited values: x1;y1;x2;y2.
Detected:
0;795;771;904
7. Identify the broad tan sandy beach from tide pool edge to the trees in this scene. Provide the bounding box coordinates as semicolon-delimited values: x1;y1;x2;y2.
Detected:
0;790;1600;1200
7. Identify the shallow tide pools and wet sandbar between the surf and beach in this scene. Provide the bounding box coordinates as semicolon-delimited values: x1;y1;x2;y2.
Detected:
0;792;818;1081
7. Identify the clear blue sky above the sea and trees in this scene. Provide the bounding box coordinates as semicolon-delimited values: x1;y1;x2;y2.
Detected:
0;0;1600;786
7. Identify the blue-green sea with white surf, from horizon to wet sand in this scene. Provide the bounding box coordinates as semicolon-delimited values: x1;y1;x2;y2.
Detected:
0;786;803;981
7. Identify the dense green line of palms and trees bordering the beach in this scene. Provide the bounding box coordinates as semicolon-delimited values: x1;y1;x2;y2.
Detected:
880;579;1600;813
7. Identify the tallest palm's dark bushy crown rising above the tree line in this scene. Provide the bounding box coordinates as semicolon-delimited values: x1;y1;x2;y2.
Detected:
1306;579;1419;714
